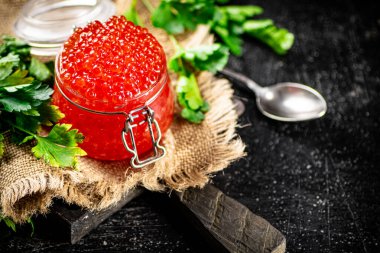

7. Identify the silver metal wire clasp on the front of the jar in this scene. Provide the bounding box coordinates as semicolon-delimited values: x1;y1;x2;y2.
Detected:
121;106;166;169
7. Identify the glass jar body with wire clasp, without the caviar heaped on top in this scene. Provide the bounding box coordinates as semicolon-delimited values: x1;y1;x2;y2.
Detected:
53;17;174;168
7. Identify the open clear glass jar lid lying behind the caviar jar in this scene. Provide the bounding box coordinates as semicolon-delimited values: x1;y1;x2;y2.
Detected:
14;0;116;56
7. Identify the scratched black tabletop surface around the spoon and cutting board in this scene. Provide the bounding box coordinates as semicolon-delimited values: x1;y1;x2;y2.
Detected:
0;0;380;252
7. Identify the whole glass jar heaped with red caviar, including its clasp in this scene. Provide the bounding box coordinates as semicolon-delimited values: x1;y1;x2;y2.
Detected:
53;17;174;168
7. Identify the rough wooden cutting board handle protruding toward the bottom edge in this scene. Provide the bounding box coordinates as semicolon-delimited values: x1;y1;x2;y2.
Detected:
177;184;286;253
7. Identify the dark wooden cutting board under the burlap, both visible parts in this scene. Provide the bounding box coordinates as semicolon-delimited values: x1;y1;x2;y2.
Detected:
37;184;286;253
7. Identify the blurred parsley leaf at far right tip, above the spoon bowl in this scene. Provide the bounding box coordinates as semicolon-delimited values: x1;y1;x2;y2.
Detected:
243;19;294;55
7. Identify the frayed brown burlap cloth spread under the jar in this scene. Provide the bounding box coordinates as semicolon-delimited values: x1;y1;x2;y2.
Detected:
0;0;244;222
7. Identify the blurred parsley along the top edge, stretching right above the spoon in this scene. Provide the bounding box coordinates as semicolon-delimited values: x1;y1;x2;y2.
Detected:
152;0;294;55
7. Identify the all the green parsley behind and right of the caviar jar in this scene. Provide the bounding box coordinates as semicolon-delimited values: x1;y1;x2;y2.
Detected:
129;0;294;123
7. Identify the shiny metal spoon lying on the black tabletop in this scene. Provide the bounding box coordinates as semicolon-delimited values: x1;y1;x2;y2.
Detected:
220;69;327;121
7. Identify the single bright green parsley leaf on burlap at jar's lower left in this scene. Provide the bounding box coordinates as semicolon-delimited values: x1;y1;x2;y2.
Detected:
32;124;86;167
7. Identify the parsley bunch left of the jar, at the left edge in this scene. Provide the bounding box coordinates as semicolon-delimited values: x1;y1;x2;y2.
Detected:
0;36;86;168
